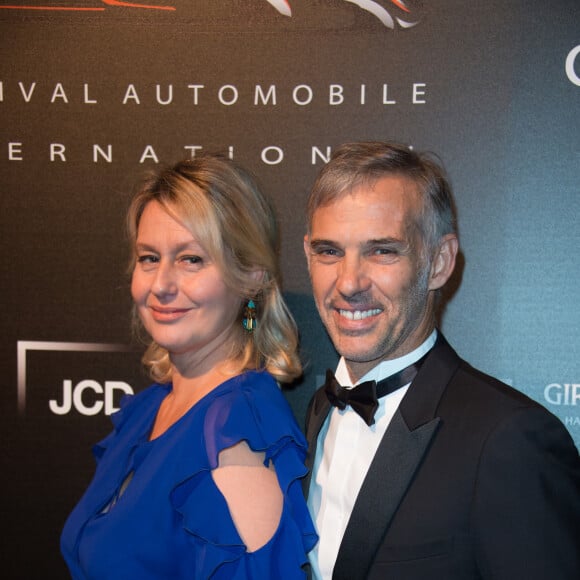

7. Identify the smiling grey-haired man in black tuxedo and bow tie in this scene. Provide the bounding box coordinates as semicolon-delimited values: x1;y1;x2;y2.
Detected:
304;143;580;580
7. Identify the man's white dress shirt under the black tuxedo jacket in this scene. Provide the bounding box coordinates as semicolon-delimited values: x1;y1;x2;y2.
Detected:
308;330;437;580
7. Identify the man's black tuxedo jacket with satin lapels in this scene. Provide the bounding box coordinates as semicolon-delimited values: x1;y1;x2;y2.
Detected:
305;335;580;580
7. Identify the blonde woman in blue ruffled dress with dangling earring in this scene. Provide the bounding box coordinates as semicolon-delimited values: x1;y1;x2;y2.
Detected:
61;156;316;580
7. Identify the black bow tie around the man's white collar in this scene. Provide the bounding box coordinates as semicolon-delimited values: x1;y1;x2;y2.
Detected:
324;355;427;427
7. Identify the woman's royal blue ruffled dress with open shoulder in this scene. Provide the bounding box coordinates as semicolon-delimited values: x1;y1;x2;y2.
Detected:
61;371;317;580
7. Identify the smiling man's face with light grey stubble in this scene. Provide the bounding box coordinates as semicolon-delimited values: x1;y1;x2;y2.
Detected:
304;176;433;380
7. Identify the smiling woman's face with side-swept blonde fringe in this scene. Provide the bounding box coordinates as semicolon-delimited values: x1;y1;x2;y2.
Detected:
131;201;241;356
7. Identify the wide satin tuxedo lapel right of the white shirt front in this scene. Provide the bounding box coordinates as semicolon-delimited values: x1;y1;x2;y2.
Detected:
333;334;459;580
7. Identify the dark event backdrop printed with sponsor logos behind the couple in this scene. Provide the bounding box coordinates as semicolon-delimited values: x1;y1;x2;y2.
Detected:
0;0;580;578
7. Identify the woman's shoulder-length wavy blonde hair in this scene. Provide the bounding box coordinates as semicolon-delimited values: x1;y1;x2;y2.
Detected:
127;154;302;382
